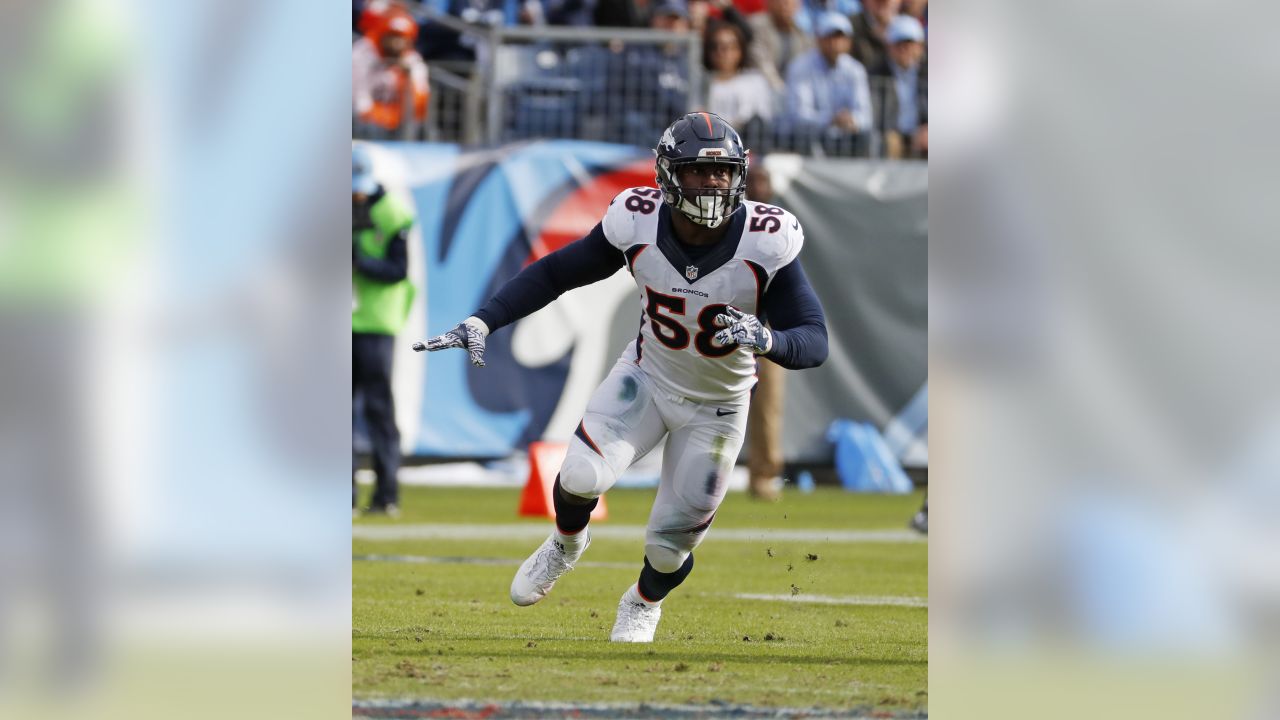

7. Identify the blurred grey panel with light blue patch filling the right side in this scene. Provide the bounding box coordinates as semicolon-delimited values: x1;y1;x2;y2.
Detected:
929;1;1280;717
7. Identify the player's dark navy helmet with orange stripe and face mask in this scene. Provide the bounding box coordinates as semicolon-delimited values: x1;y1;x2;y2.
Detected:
654;113;750;228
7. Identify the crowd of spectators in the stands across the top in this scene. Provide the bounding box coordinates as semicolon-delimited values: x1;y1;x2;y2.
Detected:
352;0;928;158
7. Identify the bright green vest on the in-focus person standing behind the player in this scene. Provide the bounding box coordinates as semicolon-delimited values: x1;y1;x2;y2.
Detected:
351;195;415;334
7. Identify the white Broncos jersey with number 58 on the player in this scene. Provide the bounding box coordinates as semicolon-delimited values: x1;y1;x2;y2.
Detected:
604;187;804;401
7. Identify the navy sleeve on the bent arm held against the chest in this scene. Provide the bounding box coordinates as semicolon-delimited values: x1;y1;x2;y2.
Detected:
762;260;827;370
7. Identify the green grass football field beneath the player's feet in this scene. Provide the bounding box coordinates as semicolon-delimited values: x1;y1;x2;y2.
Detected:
352;487;928;714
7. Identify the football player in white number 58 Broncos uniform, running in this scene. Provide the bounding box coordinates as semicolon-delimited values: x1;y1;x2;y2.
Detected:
413;113;827;642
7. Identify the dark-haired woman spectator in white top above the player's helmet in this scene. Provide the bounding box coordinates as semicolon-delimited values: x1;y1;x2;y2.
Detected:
703;22;773;126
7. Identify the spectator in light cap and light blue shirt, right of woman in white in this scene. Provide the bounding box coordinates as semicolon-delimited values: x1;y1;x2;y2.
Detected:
787;13;874;135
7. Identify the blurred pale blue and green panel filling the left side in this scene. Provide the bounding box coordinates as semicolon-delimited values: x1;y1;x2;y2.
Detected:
0;0;351;717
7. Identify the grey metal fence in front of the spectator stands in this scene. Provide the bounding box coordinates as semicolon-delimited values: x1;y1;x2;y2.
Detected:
357;10;926;156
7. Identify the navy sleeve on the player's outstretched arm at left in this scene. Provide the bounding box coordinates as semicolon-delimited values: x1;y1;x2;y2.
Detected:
475;223;626;332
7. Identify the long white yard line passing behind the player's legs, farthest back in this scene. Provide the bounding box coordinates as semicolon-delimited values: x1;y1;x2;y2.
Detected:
351;523;928;544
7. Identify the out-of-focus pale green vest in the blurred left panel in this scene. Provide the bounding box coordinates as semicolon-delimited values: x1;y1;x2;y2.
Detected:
0;0;135;299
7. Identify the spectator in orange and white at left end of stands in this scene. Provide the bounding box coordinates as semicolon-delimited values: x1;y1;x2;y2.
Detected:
351;6;430;137
